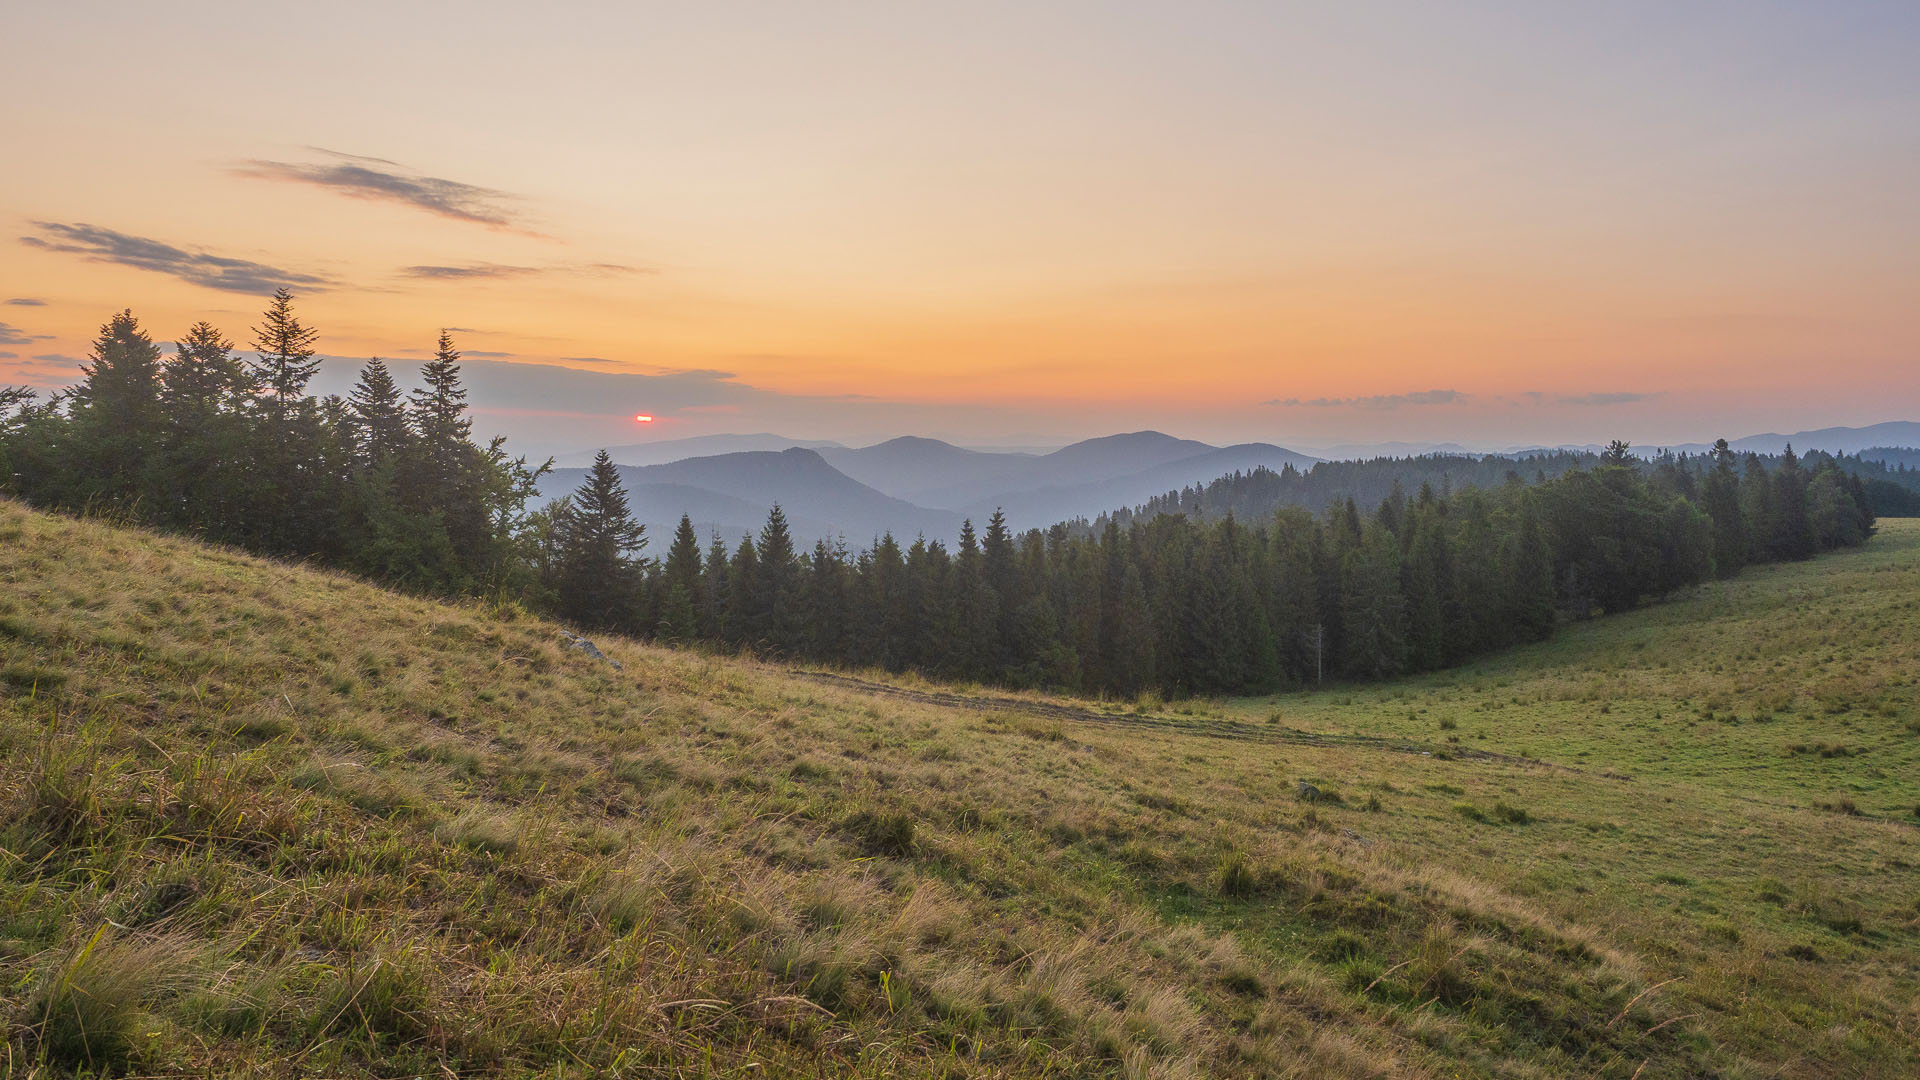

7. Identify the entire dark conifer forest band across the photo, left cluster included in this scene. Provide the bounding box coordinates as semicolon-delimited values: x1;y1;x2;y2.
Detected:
0;290;1905;696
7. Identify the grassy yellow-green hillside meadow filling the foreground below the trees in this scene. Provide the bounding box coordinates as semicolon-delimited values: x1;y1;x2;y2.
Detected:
0;502;1920;1078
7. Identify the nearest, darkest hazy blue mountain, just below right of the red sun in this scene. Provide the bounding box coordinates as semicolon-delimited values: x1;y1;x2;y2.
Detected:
540;448;960;548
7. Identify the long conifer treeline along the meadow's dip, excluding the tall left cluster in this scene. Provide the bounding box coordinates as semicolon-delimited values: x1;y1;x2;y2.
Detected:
588;444;1874;694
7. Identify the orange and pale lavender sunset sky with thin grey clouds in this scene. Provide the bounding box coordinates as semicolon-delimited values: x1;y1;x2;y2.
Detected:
0;0;1920;450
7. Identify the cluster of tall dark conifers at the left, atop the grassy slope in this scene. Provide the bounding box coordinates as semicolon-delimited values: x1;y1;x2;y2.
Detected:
0;290;536;594
